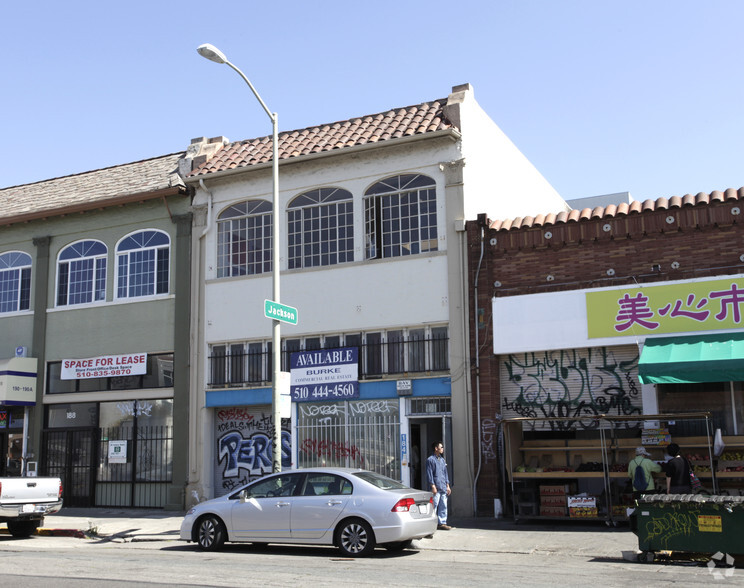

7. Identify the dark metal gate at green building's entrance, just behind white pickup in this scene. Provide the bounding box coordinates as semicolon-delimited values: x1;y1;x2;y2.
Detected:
41;429;97;507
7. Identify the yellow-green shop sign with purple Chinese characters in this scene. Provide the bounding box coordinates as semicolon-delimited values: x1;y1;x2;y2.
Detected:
586;278;744;339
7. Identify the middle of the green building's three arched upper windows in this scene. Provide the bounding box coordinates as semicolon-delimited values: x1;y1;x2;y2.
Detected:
57;240;108;306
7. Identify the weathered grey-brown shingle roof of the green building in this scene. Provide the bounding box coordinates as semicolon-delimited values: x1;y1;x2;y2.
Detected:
0;153;185;224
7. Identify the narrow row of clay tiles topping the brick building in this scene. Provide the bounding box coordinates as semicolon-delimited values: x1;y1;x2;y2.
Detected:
489;188;744;231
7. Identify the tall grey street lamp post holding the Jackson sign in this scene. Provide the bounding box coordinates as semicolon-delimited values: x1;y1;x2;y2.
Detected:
196;43;282;472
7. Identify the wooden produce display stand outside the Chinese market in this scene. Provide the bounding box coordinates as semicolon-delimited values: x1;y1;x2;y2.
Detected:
503;413;744;524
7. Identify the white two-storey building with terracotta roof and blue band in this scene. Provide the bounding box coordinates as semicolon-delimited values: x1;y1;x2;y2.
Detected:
184;85;565;514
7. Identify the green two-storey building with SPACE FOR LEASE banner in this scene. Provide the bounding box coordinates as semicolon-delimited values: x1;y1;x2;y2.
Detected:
0;154;192;509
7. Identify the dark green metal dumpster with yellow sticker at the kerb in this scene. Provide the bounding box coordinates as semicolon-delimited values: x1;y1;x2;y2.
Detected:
630;494;744;561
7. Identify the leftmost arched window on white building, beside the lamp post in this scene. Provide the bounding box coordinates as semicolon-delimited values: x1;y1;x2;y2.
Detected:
217;200;273;278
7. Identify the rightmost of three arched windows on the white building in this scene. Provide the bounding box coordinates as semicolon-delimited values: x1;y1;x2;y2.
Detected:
364;174;437;259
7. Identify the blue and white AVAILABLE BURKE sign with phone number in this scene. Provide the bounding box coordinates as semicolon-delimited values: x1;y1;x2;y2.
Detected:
290;347;359;402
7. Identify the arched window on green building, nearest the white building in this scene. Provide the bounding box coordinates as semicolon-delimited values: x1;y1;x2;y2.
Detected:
116;229;170;298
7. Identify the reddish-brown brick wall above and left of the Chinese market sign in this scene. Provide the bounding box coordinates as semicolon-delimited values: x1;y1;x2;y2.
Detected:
467;195;744;515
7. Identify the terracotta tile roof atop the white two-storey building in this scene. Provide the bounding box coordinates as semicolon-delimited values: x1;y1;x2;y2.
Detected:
189;98;456;177
